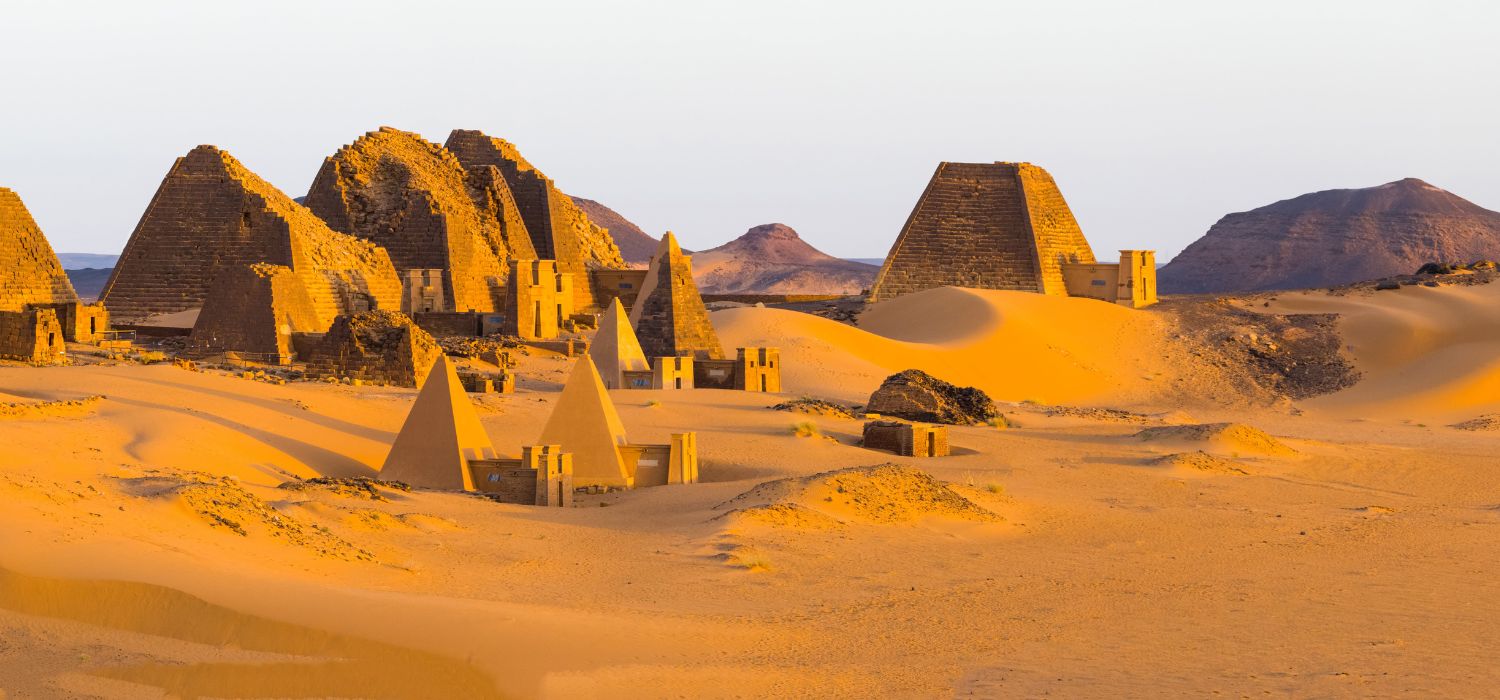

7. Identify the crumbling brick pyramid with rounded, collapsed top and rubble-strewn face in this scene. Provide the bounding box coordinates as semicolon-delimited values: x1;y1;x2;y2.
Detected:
305;126;537;312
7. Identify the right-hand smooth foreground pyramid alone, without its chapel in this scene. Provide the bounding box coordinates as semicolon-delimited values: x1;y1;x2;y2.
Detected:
537;357;635;489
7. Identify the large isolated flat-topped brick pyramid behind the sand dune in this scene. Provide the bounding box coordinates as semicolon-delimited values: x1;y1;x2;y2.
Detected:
870;163;1094;301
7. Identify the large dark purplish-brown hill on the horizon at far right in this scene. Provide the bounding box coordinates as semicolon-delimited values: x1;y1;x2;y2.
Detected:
1158;178;1500;294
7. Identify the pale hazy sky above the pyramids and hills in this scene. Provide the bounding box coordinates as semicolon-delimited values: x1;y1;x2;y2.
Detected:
0;0;1500;259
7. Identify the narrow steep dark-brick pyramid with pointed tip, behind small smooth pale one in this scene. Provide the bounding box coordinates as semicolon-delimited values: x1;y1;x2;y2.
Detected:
630;231;725;360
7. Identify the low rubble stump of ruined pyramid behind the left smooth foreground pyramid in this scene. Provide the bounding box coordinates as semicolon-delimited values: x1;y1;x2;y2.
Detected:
293;310;441;387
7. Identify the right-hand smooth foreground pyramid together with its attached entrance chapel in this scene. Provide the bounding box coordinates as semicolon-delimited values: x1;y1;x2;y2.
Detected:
537;355;698;489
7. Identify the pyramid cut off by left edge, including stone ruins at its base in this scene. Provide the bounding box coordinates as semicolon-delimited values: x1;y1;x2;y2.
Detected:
0;187;110;363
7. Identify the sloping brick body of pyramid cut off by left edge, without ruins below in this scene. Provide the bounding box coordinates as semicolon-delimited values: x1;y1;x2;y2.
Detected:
0;187;78;312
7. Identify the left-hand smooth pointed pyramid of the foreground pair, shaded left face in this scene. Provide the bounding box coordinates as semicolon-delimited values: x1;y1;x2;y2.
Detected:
380;355;495;492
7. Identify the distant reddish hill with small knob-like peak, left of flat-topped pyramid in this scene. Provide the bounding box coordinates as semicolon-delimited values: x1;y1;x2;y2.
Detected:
693;223;881;294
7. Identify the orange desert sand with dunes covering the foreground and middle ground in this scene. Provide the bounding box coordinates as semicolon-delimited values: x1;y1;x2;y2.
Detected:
0;285;1500;699
